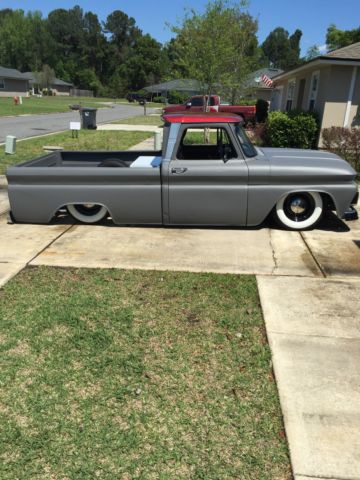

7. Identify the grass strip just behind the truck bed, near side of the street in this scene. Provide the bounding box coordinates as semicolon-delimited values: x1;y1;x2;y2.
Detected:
0;130;151;174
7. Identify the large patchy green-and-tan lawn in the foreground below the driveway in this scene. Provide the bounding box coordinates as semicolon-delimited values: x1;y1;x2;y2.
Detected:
0;267;291;480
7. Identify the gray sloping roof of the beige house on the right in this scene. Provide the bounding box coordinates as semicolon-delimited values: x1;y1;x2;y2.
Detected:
274;42;360;80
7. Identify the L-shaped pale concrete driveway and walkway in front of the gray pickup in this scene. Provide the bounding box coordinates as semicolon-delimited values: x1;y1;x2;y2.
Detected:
0;201;360;480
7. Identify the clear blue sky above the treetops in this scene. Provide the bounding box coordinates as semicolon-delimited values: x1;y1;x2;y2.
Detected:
0;0;360;53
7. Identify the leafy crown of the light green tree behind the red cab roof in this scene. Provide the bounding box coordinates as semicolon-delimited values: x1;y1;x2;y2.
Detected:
172;0;257;105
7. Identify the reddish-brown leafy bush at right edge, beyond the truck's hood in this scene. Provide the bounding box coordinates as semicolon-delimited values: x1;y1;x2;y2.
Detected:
322;127;360;173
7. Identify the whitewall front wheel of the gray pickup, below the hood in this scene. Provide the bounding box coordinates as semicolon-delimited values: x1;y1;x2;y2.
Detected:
274;192;324;230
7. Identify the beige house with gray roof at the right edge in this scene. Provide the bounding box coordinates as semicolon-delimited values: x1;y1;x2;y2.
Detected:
270;42;360;144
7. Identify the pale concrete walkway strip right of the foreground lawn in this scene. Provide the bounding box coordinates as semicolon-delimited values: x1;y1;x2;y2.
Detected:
258;276;360;480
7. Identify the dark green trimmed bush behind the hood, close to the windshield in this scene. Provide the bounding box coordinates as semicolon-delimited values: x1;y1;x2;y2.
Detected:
266;112;319;148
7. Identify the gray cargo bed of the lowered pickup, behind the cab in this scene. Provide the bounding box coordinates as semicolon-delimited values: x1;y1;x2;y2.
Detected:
7;151;162;225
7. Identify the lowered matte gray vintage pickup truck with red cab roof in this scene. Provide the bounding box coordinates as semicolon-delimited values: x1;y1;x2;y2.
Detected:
7;112;358;230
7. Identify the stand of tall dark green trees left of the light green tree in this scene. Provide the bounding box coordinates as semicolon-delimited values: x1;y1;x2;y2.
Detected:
0;6;169;94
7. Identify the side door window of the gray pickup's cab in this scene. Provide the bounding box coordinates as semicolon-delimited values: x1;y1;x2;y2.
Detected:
176;127;237;160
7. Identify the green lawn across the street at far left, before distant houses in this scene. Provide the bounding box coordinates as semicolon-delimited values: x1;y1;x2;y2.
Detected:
0;96;118;117
